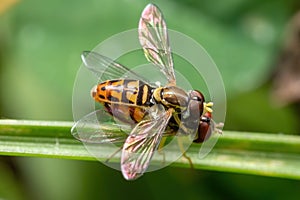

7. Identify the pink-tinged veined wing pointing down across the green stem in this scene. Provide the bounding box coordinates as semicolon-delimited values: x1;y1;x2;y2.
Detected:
121;105;172;180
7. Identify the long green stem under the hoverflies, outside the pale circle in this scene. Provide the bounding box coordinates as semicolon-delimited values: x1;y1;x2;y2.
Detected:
0;120;300;180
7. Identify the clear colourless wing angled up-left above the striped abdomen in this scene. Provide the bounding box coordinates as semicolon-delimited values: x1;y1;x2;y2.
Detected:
81;51;150;84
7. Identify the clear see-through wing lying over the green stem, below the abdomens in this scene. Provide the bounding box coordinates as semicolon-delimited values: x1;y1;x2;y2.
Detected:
71;109;131;144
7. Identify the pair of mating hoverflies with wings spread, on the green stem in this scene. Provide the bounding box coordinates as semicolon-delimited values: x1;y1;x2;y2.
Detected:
72;4;221;180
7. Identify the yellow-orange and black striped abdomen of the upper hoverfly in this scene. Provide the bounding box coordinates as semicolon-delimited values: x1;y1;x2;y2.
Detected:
92;79;153;107
